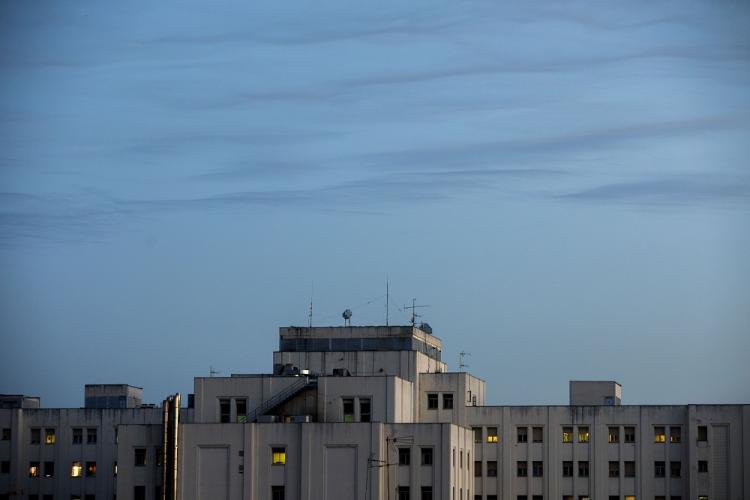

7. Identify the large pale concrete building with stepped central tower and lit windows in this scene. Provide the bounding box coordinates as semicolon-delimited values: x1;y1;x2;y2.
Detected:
0;326;750;500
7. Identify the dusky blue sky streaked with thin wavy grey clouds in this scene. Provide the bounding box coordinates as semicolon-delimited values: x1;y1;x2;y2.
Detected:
0;0;750;407
